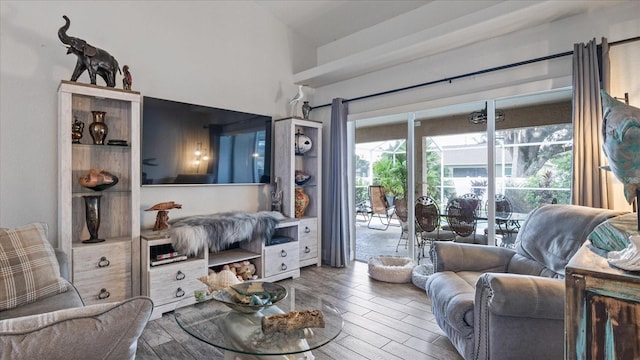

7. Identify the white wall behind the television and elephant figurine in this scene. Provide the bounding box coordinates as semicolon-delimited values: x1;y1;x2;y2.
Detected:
0;0;314;243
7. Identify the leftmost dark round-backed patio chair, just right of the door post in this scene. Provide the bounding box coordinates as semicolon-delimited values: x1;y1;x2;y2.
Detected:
415;196;455;261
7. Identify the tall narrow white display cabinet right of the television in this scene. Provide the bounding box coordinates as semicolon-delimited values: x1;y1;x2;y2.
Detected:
273;118;322;267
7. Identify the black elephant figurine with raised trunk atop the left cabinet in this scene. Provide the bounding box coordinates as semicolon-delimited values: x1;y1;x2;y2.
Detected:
58;15;120;87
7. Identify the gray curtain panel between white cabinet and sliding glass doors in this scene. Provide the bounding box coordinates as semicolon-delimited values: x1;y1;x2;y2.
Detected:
322;99;353;267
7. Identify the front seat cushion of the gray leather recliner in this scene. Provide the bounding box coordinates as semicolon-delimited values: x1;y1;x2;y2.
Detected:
426;271;482;337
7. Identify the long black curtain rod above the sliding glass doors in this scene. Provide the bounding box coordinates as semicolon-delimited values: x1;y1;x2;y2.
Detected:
311;36;640;110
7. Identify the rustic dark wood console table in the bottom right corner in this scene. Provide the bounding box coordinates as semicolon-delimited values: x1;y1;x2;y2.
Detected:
565;241;640;360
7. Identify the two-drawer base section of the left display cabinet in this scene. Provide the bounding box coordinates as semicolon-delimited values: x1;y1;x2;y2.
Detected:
72;241;131;305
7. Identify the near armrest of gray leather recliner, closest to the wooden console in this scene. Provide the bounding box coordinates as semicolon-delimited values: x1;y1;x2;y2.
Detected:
475;273;565;320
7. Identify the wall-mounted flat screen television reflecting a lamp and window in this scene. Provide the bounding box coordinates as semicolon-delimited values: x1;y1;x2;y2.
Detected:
140;96;272;185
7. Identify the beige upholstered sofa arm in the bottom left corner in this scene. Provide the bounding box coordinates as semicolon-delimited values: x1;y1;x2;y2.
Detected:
0;297;153;360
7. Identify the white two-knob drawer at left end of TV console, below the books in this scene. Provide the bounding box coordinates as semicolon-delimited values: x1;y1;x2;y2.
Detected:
147;260;207;306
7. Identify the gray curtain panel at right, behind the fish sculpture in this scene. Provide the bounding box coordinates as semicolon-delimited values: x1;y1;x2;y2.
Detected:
572;38;613;209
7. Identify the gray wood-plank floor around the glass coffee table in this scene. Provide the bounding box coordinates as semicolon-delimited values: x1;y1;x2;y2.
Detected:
136;262;462;360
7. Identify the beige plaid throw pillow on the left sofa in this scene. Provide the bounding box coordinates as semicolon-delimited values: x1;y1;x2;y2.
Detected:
0;223;67;311
